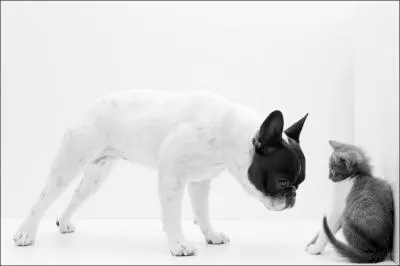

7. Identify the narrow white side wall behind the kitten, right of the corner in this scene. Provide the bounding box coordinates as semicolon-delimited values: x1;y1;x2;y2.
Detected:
354;2;399;263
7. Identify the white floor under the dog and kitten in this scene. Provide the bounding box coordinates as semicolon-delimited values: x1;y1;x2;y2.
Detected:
1;219;395;265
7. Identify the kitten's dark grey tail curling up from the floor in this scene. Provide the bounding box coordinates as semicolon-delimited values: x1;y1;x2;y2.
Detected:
323;217;387;263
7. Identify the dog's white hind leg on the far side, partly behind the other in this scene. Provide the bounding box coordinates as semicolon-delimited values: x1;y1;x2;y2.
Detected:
57;152;118;233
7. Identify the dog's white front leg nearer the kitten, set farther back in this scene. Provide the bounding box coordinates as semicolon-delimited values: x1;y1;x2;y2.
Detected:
188;180;229;245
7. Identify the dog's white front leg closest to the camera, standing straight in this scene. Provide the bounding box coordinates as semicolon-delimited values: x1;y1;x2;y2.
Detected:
159;175;196;256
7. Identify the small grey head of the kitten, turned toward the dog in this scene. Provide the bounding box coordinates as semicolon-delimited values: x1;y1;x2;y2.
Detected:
329;140;371;182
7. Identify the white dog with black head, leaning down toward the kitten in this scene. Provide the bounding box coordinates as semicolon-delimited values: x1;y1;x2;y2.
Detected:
13;90;308;256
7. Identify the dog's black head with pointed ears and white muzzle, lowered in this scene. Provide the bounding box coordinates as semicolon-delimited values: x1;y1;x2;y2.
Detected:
248;111;308;211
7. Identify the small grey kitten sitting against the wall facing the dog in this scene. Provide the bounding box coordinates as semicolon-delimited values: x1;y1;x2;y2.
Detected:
323;141;394;263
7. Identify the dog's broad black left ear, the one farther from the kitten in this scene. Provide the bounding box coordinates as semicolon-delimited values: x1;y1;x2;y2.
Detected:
257;110;283;146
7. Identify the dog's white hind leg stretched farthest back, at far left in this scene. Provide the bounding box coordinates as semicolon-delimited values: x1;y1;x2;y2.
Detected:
14;129;102;246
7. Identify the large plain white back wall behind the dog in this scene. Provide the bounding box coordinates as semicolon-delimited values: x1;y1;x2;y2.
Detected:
1;2;355;220
